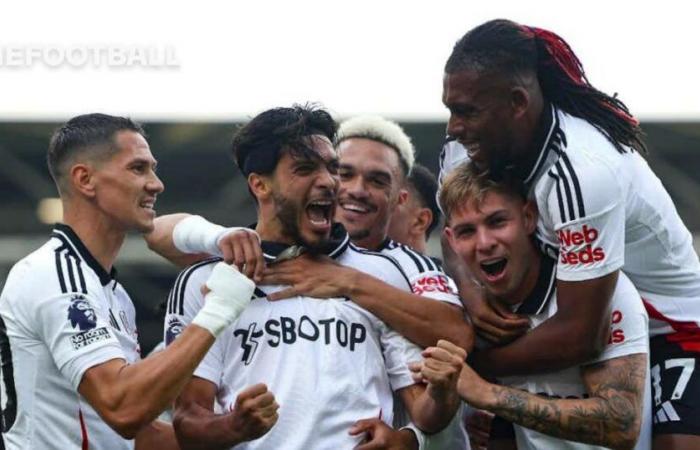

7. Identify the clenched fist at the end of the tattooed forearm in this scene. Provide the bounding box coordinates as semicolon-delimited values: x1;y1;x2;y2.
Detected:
409;339;467;399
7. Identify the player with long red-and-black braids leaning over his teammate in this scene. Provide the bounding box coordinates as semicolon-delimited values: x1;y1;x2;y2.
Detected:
442;20;700;449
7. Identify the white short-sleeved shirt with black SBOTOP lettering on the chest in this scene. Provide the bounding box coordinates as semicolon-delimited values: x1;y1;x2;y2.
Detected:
165;225;422;449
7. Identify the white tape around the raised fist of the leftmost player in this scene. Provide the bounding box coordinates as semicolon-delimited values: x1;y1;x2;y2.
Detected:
192;262;255;337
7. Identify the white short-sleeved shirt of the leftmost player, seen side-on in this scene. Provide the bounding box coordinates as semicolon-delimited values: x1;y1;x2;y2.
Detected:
0;225;140;449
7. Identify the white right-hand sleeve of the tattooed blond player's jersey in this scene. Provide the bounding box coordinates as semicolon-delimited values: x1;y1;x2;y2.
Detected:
591;273;649;363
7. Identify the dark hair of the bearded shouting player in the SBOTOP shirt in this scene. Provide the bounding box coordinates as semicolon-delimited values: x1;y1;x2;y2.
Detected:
231;104;338;176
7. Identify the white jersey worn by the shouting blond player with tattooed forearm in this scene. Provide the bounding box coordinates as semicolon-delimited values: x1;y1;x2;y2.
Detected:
500;257;651;450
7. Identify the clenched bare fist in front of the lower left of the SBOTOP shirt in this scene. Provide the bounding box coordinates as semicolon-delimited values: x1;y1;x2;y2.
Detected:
227;383;279;443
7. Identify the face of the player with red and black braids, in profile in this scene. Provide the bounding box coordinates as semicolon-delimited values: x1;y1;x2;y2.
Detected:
442;70;515;171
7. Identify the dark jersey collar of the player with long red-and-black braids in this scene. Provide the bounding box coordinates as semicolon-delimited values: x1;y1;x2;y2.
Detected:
519;103;566;190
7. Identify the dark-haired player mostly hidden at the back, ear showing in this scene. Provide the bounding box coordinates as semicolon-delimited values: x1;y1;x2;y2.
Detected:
388;163;440;254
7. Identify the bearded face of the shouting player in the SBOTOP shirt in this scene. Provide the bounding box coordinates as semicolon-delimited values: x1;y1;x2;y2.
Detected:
271;135;338;250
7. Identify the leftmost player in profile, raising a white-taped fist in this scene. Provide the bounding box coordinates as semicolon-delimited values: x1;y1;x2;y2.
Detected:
0;114;254;449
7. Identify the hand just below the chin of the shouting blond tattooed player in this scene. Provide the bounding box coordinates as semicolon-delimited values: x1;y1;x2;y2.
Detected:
464;295;530;345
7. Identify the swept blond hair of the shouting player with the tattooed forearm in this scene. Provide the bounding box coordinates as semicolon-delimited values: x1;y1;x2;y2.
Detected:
440;161;527;223
